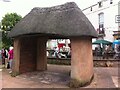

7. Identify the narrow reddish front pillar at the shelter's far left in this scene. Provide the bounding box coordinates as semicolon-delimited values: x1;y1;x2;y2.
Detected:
12;38;21;73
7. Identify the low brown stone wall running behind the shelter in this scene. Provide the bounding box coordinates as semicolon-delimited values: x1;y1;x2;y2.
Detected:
47;58;120;67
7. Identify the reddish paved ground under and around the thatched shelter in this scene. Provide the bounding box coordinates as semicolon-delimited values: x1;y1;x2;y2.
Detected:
0;64;120;88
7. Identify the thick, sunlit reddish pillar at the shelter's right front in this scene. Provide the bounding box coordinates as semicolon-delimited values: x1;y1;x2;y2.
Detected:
71;37;93;86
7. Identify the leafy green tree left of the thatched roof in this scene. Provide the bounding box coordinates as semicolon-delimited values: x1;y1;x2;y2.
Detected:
1;13;22;48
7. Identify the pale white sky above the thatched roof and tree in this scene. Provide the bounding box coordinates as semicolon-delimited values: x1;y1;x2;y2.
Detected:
0;0;96;20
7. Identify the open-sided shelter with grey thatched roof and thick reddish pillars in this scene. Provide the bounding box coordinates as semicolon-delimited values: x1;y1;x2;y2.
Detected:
9;2;97;84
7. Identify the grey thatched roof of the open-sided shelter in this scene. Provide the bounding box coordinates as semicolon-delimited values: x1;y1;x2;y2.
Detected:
9;2;97;37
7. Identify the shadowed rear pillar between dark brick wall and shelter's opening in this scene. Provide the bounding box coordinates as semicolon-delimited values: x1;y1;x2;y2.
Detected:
37;37;47;71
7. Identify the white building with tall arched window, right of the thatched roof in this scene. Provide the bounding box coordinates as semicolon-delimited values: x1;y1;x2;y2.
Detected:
82;0;120;41
